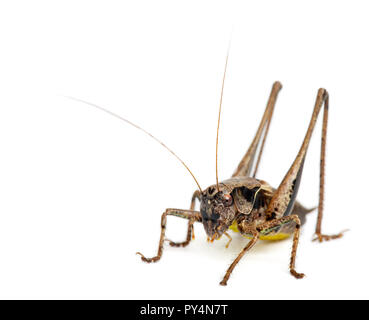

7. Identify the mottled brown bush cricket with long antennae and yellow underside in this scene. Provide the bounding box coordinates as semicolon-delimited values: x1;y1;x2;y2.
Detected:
68;67;343;285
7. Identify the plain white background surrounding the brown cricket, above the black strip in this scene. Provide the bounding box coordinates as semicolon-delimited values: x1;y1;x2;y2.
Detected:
0;0;369;299
